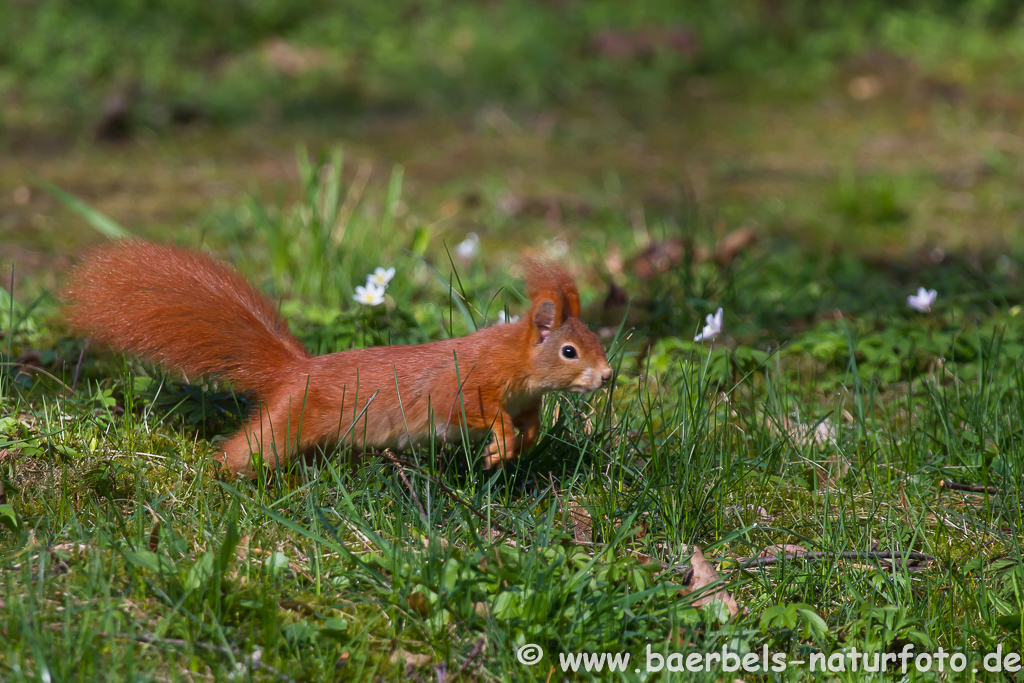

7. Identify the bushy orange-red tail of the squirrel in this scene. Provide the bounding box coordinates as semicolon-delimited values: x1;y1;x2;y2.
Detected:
63;241;309;396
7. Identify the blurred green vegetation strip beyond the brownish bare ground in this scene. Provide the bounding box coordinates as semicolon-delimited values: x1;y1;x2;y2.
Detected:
6;0;1024;135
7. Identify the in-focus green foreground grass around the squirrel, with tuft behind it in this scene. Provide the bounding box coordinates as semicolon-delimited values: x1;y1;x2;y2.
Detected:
6;153;1024;681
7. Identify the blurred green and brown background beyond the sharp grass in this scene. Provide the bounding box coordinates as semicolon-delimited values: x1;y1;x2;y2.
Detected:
6;0;1024;284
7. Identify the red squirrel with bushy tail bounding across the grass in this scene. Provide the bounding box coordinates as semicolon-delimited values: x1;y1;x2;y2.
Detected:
65;241;611;477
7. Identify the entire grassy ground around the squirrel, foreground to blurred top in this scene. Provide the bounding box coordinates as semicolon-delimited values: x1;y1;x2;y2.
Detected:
9;0;1024;681
